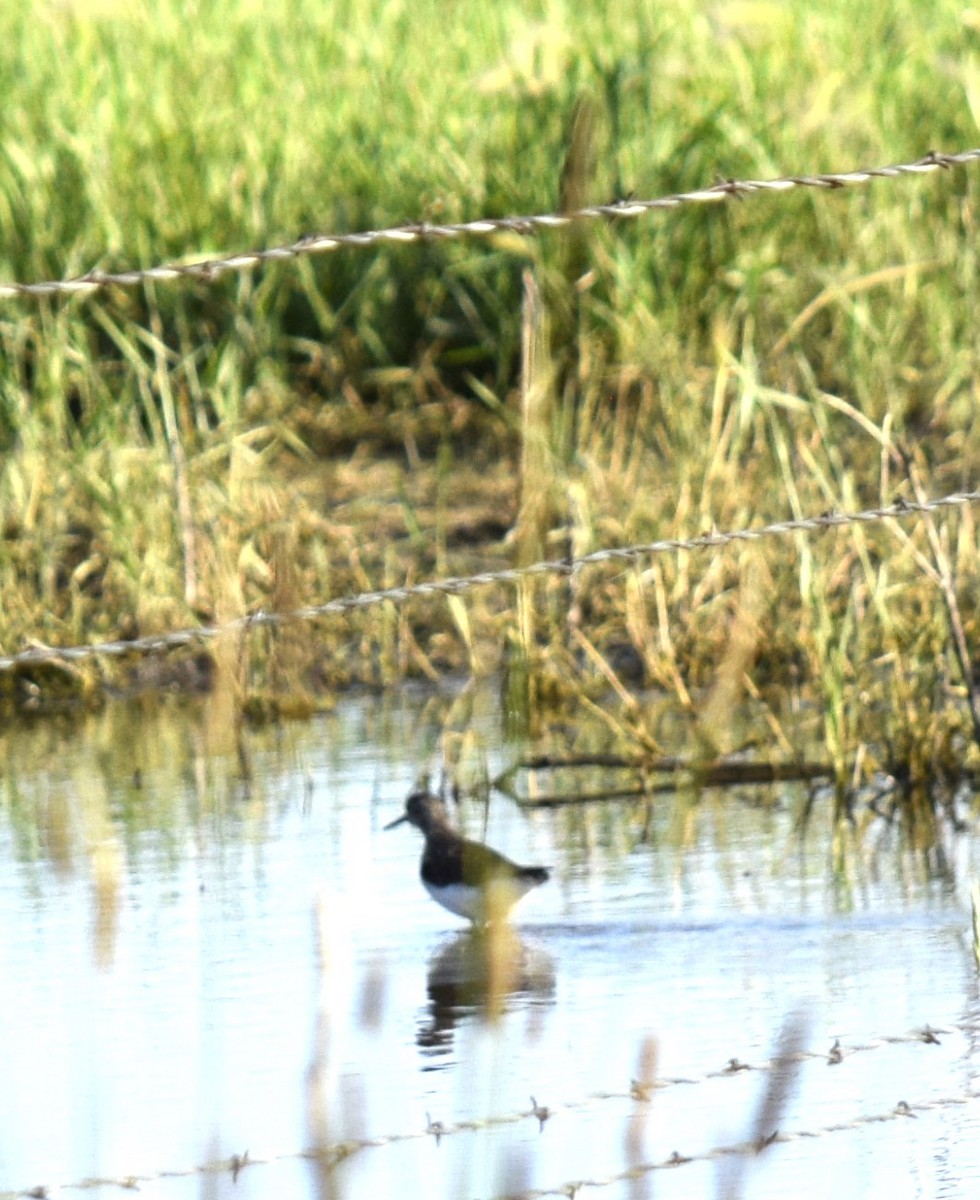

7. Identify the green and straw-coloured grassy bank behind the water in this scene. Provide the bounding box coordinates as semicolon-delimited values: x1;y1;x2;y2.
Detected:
0;0;980;812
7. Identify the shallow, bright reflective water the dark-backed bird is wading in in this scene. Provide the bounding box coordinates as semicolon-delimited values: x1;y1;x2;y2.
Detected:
0;692;980;1200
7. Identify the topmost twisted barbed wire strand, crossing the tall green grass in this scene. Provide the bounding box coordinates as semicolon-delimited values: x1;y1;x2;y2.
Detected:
0;149;980;300
